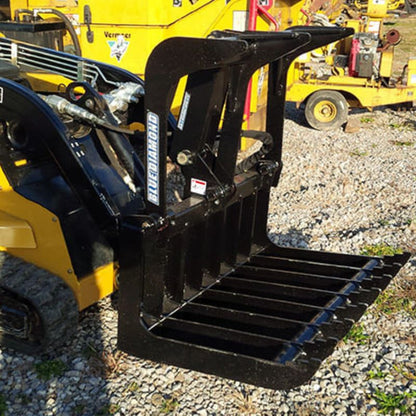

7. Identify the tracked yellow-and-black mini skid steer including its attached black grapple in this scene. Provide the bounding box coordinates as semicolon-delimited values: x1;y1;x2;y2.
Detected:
0;27;408;389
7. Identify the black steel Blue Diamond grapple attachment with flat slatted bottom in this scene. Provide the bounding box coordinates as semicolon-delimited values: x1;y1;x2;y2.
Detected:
119;27;408;389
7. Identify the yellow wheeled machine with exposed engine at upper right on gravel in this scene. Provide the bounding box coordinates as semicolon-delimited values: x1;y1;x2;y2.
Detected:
286;1;416;130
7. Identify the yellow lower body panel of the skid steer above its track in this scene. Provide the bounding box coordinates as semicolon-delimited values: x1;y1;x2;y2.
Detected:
0;168;116;309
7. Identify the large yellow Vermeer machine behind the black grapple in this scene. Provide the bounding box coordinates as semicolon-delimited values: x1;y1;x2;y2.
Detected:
0;0;296;128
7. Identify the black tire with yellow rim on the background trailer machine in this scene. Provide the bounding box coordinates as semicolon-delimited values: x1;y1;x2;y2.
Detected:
305;90;348;131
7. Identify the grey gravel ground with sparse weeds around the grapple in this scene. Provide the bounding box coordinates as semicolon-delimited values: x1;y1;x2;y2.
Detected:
0;108;416;416
